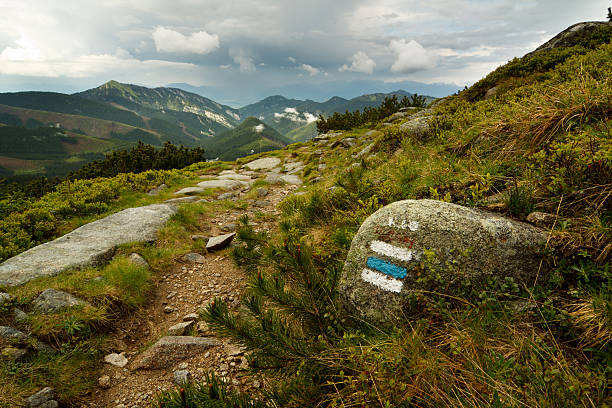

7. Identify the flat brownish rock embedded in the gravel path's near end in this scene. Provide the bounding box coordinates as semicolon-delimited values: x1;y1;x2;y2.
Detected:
132;336;221;370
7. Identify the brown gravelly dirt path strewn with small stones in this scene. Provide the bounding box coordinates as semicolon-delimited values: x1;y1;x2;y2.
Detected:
83;178;297;408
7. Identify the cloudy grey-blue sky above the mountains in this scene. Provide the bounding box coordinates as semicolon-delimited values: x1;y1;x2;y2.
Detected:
0;0;609;107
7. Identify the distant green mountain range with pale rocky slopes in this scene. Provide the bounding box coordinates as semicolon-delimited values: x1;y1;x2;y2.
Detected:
0;81;434;176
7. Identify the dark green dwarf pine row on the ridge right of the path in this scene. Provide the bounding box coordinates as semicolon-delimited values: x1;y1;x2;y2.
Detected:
317;94;427;133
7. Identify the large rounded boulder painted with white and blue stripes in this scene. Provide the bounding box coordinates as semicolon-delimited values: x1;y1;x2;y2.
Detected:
340;200;546;322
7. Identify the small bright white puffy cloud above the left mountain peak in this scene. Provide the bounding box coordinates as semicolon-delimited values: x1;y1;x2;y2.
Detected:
153;27;219;54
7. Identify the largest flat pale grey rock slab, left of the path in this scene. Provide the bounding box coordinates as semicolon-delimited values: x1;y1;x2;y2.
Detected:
0;204;176;286
